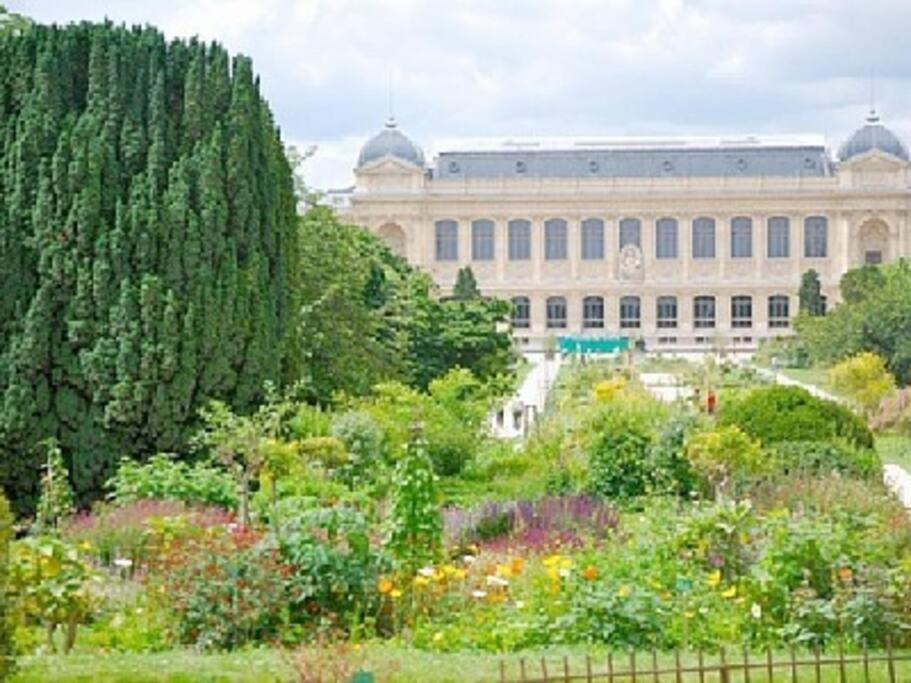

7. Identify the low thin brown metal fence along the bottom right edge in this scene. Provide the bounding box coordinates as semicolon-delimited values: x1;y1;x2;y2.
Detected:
499;647;911;683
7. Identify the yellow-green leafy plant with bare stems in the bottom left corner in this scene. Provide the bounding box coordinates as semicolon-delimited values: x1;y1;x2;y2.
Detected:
9;536;94;653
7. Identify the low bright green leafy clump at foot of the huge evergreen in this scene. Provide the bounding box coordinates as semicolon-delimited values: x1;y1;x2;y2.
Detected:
107;453;237;509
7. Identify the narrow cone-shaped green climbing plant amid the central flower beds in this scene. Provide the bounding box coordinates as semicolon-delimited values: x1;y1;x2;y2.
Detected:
386;430;443;573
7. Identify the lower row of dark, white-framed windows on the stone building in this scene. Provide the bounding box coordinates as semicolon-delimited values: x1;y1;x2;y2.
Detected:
512;294;790;329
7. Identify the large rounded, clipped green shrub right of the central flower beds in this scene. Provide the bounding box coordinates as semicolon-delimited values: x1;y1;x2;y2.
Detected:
719;385;873;448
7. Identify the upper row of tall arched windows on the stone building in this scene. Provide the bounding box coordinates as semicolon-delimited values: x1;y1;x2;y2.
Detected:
435;216;829;261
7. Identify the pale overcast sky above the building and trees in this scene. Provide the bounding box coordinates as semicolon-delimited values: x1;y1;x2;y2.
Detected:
2;0;911;188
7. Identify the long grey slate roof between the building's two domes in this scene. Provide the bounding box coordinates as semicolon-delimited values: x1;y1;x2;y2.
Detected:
433;145;832;179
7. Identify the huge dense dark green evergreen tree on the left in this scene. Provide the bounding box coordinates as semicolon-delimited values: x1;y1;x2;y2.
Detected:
0;24;301;511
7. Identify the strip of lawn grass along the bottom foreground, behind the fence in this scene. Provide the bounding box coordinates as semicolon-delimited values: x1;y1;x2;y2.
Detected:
13;644;911;683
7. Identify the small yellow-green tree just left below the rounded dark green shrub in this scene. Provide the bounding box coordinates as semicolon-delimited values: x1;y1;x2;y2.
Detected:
686;425;768;498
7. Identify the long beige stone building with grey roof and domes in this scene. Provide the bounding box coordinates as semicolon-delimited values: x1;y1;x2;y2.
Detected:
335;112;911;350
